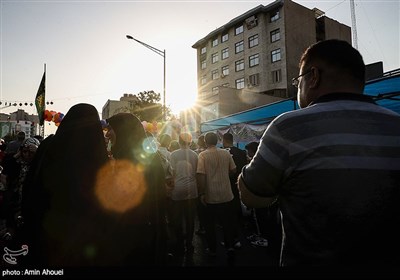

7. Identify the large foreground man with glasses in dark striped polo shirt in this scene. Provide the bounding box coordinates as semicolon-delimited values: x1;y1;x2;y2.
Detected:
239;40;400;268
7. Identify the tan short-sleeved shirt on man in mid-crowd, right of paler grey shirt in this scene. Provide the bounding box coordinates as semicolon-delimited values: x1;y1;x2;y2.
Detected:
197;147;236;204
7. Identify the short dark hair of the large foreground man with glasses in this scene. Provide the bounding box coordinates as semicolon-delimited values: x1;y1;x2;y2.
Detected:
299;39;365;84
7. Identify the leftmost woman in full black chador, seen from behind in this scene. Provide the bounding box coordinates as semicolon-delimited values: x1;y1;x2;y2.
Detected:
22;104;108;266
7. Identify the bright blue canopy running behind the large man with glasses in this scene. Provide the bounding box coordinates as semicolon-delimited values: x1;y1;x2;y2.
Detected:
200;73;400;135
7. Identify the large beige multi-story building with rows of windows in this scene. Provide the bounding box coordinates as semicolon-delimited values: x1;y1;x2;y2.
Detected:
192;0;351;122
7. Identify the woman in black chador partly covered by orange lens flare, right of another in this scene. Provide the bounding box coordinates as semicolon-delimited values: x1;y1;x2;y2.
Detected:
104;113;167;265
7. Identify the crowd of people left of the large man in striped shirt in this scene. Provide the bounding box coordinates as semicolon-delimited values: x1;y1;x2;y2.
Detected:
1;110;272;267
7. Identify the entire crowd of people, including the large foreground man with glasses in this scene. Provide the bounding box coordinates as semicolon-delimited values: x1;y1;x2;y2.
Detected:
0;40;400;276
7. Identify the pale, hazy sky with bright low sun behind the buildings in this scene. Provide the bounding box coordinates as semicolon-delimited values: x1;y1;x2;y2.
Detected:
0;0;400;132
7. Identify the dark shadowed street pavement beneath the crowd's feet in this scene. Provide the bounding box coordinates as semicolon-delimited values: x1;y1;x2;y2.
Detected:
0;213;279;280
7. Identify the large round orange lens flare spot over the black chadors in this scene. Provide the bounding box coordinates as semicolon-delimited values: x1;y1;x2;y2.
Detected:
95;160;147;213
